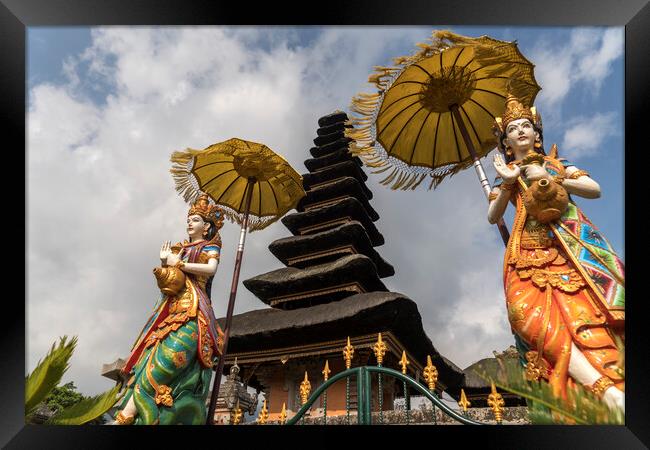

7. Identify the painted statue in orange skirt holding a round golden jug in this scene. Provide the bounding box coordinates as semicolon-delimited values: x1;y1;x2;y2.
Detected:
488;96;625;411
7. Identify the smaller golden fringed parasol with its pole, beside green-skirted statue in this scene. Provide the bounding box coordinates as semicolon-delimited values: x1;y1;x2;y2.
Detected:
171;138;306;425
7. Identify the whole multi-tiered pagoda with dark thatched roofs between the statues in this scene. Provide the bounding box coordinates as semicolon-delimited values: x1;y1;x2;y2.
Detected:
219;111;463;420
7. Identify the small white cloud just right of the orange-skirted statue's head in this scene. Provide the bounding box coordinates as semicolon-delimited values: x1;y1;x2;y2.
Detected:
561;112;620;160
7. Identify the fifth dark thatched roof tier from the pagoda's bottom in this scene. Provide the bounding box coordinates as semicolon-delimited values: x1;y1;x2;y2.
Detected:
296;177;379;222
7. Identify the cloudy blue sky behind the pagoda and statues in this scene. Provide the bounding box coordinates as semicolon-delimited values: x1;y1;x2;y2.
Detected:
27;25;624;393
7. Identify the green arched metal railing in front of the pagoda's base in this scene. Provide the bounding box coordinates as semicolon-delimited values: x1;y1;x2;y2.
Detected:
286;366;486;425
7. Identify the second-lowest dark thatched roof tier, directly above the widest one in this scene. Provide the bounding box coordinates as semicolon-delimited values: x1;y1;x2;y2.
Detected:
244;255;387;309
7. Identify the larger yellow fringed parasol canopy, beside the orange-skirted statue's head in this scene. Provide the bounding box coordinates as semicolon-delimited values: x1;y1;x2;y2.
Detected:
346;31;541;189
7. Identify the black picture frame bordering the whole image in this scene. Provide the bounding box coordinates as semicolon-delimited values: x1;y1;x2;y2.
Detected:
0;0;650;449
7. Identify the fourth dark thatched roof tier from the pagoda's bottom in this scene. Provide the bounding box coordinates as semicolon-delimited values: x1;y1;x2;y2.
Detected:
282;197;384;247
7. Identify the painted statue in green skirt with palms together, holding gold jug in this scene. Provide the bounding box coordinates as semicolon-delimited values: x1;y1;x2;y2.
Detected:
115;194;223;425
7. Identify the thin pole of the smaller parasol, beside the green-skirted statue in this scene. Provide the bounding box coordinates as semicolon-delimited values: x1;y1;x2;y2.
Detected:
206;178;257;425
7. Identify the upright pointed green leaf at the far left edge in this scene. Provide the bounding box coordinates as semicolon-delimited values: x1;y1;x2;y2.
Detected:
25;336;77;416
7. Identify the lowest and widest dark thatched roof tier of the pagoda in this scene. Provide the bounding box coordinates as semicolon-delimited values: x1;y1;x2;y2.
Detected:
217;292;464;391
